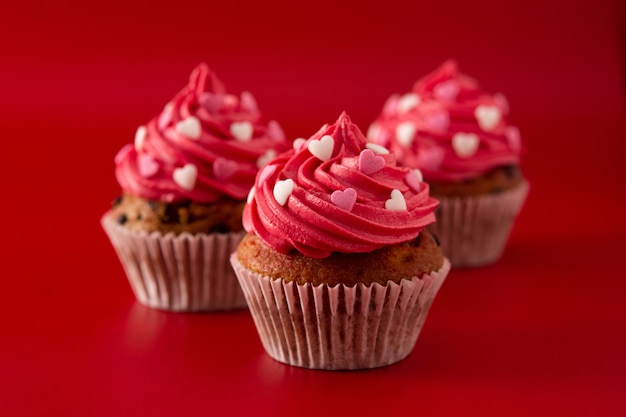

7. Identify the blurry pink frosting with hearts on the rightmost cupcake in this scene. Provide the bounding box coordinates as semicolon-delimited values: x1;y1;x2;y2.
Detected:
368;61;521;182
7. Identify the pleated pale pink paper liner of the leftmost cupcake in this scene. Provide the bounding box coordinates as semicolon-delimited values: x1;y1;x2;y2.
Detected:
101;214;246;312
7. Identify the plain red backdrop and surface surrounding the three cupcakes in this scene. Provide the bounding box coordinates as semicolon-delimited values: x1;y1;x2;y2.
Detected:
0;0;626;416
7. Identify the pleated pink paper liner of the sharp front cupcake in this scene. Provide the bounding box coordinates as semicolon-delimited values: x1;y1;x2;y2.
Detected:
231;254;450;370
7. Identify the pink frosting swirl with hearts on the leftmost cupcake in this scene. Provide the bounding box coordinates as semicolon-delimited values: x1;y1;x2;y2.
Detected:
115;64;289;203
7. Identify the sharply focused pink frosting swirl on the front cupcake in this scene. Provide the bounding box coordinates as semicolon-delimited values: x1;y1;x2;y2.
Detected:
243;113;437;258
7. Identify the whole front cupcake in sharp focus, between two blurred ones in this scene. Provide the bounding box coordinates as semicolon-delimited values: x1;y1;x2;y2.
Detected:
231;113;450;369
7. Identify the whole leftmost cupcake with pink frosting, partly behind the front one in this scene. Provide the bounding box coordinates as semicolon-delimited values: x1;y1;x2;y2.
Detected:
101;64;290;311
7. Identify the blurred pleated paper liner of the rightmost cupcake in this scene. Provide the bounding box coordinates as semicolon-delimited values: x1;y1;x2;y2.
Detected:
428;181;529;268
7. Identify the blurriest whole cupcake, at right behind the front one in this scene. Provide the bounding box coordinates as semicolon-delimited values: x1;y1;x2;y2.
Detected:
367;61;529;267
